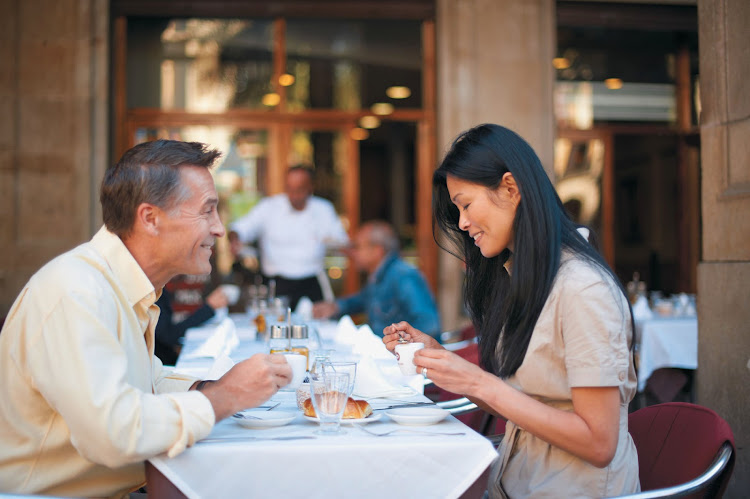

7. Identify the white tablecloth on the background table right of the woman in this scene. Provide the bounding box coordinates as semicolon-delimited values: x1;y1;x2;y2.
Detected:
635;317;698;391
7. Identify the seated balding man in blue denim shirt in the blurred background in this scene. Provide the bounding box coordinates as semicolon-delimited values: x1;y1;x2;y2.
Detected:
313;220;440;340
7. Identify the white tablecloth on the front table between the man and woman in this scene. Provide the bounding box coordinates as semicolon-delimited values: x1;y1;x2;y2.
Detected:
147;318;497;498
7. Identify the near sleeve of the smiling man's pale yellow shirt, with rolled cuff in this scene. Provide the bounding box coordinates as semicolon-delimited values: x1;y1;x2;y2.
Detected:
29;289;215;467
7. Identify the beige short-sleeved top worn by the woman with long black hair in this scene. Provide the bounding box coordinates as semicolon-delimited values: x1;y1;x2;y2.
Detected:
489;254;640;498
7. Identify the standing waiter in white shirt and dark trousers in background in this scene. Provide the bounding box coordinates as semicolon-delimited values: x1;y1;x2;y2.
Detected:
229;166;349;308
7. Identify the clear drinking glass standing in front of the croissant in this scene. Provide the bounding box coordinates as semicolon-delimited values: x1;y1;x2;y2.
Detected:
310;372;349;435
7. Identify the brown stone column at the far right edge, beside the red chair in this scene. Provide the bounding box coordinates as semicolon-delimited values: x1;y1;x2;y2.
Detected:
696;0;750;498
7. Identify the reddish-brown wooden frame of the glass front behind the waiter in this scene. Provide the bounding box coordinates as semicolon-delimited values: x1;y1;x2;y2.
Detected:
112;15;438;292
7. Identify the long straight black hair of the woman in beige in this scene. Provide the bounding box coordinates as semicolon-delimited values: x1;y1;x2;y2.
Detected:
432;124;625;378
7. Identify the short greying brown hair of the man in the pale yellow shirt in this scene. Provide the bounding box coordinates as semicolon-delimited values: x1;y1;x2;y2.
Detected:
99;140;221;237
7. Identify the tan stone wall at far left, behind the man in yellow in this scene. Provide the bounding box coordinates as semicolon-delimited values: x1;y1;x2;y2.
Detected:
0;0;109;318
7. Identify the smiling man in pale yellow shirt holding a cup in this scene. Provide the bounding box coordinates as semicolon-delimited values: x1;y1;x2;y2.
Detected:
0;141;291;497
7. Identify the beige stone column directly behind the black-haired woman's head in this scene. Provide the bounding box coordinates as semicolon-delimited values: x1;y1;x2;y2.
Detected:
436;0;556;330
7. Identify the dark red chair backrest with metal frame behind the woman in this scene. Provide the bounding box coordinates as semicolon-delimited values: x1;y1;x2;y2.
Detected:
628;402;736;497
